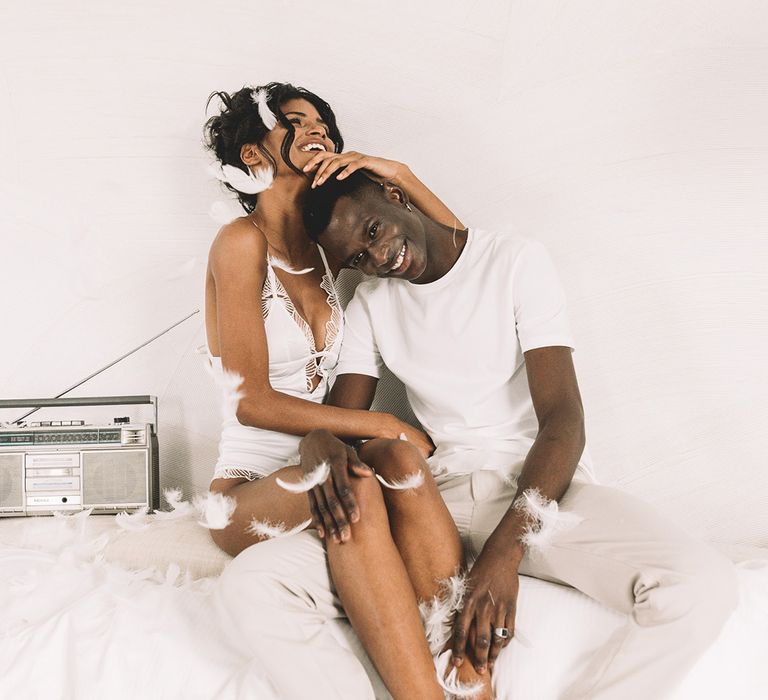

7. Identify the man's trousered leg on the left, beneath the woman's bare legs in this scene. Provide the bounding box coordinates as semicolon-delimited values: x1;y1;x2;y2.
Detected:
211;530;374;700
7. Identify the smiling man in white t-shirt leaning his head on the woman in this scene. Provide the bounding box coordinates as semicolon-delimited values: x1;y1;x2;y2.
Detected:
305;173;737;700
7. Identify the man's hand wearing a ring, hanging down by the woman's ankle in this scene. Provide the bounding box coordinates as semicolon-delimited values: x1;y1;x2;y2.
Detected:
451;542;522;673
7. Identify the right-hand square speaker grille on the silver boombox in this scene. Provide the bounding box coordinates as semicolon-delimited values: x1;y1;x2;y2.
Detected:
83;450;147;507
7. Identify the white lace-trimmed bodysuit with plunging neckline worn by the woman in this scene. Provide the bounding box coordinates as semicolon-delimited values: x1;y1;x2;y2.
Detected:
208;246;344;479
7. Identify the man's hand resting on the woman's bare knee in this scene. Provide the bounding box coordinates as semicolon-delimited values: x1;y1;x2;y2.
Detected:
299;430;373;542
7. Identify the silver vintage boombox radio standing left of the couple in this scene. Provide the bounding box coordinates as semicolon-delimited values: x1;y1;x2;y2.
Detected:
0;396;159;517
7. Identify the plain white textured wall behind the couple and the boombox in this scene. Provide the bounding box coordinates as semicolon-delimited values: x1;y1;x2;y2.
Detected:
0;0;768;546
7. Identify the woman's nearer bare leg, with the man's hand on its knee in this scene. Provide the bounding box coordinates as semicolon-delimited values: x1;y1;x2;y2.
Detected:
211;466;444;700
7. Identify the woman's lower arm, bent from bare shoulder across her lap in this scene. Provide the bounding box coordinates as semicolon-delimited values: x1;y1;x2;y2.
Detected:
210;219;403;438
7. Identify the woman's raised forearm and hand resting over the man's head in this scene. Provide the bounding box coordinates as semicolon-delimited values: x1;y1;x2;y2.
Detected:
304;151;464;230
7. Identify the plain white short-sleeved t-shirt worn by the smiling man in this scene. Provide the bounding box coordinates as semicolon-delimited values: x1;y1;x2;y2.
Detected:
337;229;595;481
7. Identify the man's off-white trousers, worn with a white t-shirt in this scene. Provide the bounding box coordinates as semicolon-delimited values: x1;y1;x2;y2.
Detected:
214;471;738;700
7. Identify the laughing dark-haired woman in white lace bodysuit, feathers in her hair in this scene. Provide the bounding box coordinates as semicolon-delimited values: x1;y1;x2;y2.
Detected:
205;83;492;699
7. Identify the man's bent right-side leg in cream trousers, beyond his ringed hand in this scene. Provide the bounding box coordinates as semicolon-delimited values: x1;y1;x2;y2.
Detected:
462;472;738;700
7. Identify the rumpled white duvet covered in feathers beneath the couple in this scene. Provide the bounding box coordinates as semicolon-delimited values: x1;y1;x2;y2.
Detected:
0;508;768;700
